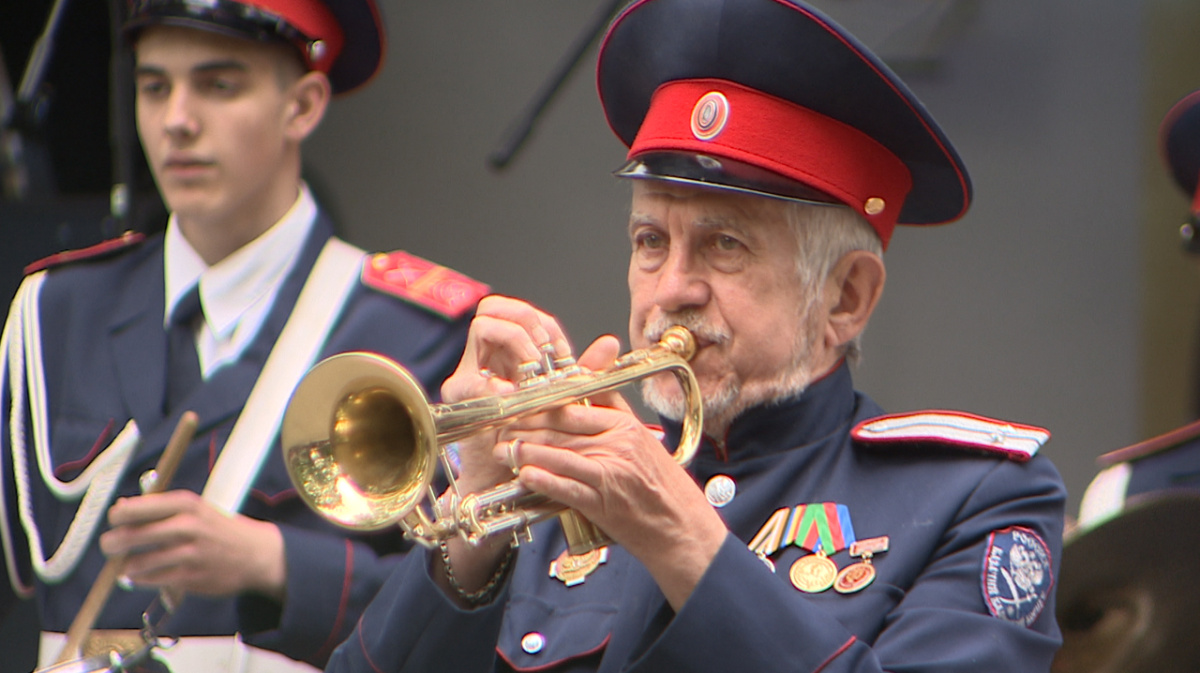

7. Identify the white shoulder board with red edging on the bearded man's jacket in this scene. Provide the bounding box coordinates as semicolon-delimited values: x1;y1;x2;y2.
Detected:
850;410;1050;463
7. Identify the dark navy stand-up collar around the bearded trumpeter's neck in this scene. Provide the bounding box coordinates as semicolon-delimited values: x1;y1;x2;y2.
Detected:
664;361;856;462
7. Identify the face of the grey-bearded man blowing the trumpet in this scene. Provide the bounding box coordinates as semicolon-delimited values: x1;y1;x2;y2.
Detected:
629;180;820;433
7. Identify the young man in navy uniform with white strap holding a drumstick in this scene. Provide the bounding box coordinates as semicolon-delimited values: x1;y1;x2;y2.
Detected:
0;0;486;672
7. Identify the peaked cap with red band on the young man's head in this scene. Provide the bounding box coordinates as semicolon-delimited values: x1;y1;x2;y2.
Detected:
124;0;386;94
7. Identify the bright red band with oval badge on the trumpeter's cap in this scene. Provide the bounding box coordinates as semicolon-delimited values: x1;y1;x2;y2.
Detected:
629;79;912;246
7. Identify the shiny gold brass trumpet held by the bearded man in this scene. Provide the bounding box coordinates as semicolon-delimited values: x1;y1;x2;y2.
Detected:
281;326;703;554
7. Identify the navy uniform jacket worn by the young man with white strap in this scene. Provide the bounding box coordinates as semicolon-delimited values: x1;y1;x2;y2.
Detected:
0;216;473;666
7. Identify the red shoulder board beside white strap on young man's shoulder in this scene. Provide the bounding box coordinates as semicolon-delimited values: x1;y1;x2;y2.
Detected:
362;251;491;319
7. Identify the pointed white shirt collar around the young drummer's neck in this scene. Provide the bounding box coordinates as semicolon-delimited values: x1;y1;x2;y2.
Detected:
163;182;317;339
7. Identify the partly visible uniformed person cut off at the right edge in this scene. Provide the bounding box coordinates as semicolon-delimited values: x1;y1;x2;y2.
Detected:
1055;91;1200;673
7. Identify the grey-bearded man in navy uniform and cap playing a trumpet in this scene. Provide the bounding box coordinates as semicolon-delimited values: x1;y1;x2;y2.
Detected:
329;0;1064;673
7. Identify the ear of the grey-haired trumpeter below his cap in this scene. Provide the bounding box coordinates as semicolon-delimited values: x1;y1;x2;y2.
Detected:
824;250;887;349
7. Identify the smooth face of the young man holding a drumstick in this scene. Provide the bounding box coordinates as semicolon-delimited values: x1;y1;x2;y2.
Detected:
136;26;295;230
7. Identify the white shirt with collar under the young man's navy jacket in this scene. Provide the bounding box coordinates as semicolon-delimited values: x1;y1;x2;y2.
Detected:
163;184;317;379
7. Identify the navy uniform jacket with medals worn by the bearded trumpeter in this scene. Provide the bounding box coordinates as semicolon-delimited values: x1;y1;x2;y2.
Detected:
328;366;1066;673
